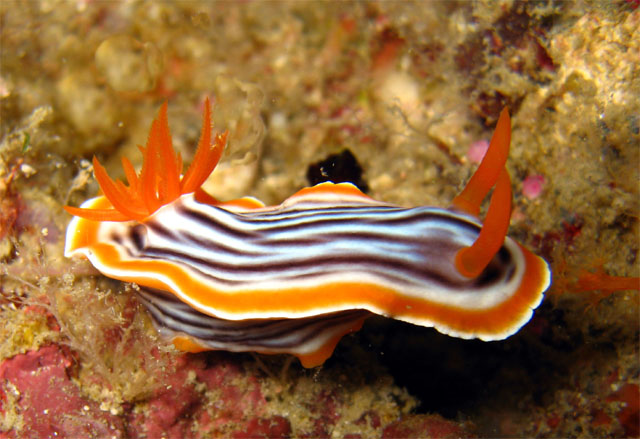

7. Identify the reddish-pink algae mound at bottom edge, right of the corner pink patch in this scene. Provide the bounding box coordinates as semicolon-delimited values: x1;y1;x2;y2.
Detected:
128;354;268;439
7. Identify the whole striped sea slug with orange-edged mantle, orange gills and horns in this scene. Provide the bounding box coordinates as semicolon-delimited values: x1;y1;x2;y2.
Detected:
65;101;551;367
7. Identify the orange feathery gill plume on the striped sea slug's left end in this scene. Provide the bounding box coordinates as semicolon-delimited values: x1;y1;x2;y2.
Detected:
64;99;228;221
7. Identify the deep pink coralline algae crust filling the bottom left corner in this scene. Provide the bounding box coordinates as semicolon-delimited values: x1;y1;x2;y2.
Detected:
0;345;124;439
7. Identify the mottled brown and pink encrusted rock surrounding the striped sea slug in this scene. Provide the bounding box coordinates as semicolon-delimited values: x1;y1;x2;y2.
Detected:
0;0;640;438
